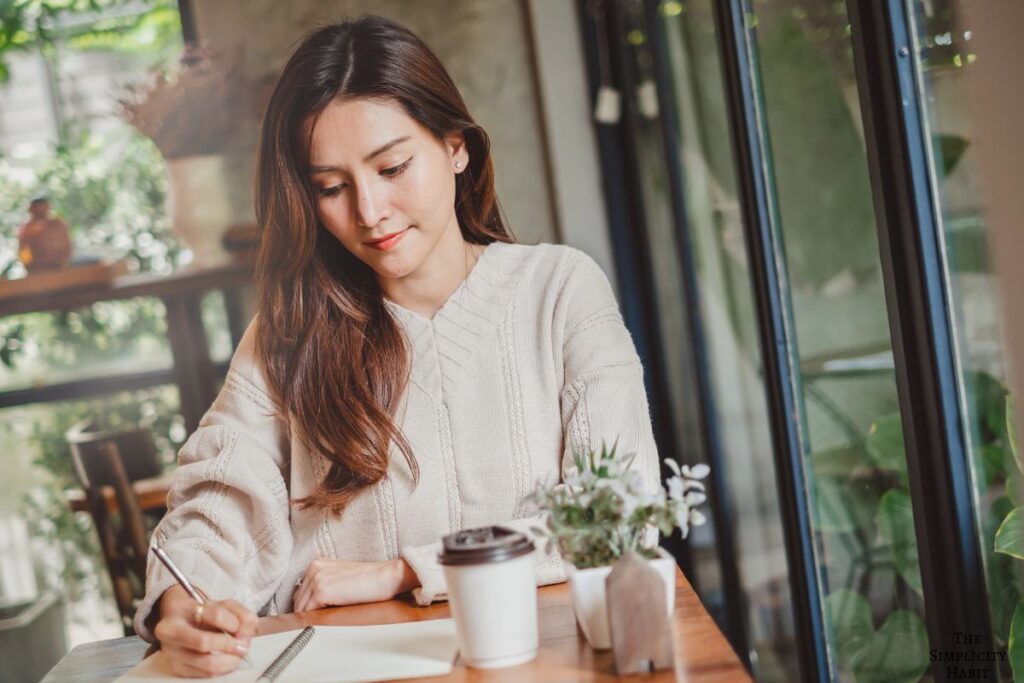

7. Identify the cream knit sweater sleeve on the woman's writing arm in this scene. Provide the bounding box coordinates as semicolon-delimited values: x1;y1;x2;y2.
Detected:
135;328;293;642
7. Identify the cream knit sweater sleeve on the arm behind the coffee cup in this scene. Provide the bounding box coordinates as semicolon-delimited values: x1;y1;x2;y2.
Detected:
401;251;660;605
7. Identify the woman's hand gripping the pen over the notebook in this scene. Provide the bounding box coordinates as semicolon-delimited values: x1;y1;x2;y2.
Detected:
153;586;256;678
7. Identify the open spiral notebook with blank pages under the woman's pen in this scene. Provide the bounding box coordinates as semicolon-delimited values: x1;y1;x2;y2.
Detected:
116;618;459;683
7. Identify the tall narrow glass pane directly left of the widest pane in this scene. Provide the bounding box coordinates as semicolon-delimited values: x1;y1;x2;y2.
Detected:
659;0;799;681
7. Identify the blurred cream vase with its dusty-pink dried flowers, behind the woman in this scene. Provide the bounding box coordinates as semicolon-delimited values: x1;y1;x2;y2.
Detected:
119;46;264;263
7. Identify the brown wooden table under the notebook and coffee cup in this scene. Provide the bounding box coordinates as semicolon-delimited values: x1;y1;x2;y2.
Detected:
43;571;751;683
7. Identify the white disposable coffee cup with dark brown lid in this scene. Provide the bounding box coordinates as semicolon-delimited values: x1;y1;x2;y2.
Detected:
437;526;538;669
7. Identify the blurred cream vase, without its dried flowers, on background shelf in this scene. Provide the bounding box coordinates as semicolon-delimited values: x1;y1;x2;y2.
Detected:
167;155;232;265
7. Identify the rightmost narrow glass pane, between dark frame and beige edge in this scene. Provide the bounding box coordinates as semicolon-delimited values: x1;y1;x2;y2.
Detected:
909;0;1024;680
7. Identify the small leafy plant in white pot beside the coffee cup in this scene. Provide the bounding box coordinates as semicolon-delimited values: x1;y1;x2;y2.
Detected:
531;445;710;649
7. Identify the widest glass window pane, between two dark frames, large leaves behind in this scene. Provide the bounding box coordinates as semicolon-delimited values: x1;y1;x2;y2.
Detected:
744;0;930;681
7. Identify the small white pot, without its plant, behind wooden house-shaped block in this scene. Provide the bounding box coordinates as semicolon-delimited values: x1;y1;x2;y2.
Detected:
564;548;676;650
